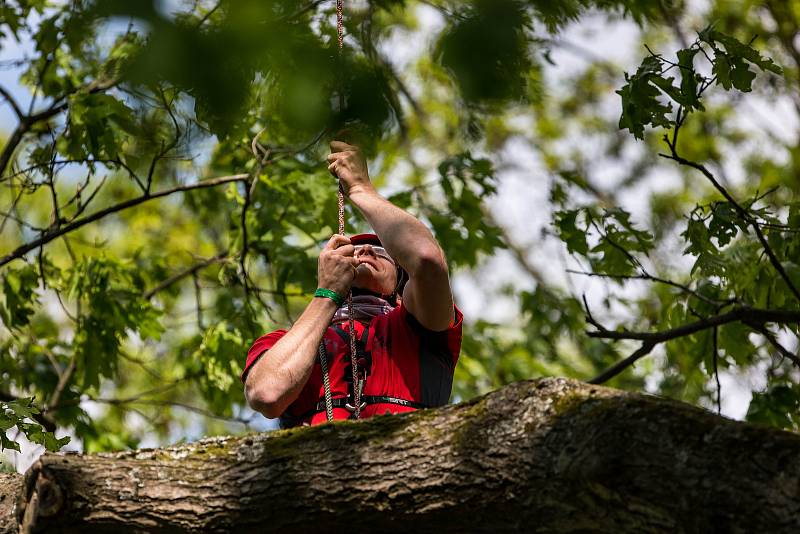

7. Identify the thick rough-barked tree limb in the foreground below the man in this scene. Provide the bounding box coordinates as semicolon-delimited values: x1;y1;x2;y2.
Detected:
0;379;800;533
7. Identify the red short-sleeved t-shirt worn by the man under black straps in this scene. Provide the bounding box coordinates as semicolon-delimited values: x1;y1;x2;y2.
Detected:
242;303;463;425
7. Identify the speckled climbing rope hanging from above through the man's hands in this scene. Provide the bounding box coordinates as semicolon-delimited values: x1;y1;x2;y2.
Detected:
319;0;366;421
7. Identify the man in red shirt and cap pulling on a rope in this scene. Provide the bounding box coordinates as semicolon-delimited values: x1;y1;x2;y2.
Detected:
242;141;462;426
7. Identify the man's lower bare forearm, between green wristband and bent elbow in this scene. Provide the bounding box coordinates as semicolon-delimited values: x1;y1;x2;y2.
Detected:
245;298;336;417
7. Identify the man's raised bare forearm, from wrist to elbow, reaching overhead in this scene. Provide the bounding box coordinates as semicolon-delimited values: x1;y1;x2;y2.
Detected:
350;189;446;276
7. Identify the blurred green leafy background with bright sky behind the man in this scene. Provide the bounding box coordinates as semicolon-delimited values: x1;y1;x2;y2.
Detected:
0;0;800;462
